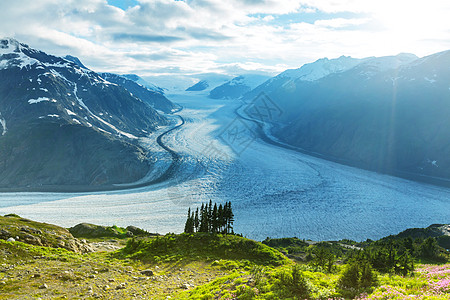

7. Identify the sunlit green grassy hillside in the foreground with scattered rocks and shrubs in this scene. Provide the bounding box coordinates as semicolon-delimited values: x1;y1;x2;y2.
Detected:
0;215;450;299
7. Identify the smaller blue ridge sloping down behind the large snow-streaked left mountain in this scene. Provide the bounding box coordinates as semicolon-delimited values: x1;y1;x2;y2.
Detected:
100;73;179;113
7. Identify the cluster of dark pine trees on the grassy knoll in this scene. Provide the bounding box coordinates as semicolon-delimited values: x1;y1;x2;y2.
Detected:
184;200;234;234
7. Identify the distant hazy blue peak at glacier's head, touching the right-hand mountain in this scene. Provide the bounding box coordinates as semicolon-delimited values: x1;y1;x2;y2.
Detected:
209;74;269;99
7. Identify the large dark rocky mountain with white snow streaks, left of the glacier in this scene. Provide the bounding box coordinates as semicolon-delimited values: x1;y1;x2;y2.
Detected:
0;38;167;188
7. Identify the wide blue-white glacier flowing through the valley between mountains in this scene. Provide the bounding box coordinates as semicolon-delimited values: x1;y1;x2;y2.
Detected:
0;92;450;240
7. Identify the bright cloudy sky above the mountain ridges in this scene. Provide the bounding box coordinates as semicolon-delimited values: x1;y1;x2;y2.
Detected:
0;0;450;81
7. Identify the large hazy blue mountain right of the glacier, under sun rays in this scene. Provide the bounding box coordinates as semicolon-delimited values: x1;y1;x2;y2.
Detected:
253;51;450;181
